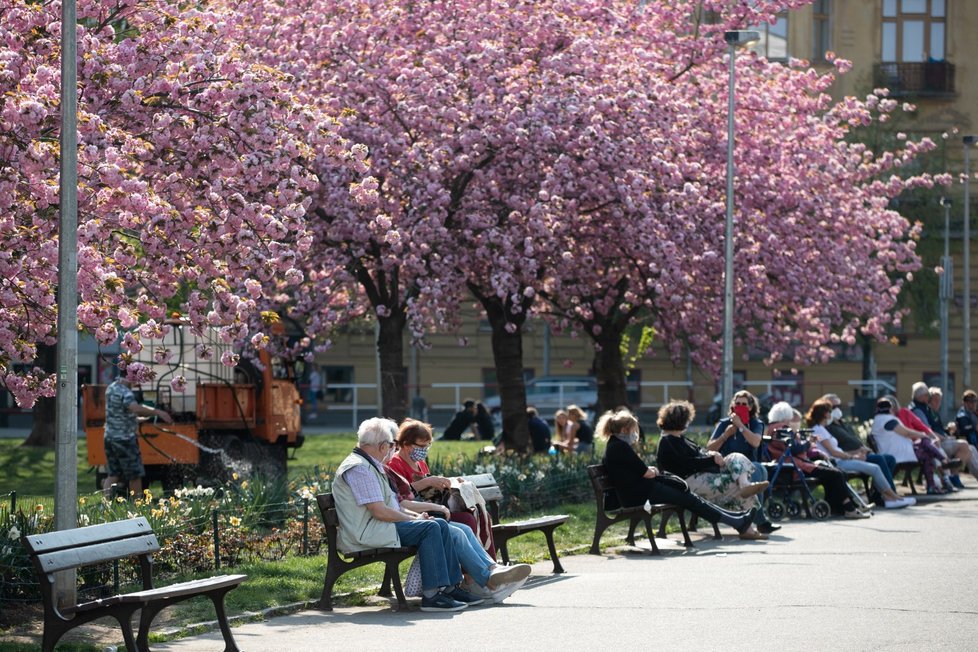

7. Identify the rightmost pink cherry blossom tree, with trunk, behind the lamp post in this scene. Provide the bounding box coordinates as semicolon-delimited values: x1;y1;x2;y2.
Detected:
542;52;947;409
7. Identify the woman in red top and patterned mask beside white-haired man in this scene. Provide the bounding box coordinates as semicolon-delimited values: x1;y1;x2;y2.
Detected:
384;419;496;559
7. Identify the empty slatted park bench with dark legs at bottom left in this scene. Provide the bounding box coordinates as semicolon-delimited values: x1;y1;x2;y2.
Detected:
21;517;247;652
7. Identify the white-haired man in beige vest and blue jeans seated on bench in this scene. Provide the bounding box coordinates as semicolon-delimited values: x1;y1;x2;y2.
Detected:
333;418;530;611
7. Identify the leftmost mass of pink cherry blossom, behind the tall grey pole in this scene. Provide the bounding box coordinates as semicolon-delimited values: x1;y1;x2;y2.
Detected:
0;0;352;444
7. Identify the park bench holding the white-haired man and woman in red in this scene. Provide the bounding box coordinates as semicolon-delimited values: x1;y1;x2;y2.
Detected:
316;473;569;611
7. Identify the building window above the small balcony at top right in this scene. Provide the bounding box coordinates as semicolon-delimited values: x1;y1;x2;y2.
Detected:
880;0;947;63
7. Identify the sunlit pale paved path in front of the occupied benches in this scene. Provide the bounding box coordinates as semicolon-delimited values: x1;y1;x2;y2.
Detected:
154;478;978;652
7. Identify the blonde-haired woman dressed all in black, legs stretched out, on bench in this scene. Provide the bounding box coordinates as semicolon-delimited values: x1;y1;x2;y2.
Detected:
597;410;755;534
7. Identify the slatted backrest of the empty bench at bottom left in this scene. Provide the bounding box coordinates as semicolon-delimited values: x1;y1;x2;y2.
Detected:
21;517;160;574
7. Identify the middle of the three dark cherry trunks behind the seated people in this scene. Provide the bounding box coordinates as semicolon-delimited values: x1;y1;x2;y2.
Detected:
472;289;530;453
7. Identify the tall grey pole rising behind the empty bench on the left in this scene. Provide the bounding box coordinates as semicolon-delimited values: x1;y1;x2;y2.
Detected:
54;0;78;605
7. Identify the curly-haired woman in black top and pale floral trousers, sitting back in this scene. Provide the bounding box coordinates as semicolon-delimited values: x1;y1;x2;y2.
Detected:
656;401;768;539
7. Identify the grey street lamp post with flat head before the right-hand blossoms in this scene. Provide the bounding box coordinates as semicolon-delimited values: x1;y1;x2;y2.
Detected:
720;30;760;405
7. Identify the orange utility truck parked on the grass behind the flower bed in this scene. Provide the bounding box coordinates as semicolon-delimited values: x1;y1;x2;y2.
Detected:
82;323;303;489
